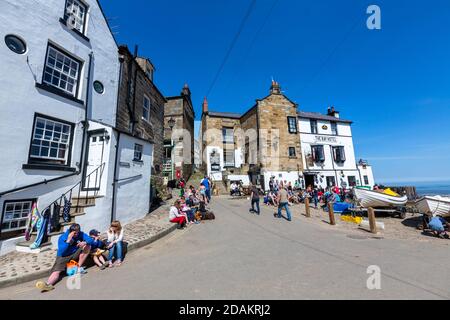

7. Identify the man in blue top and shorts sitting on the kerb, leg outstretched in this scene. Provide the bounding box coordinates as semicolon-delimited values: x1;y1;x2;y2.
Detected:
36;223;97;292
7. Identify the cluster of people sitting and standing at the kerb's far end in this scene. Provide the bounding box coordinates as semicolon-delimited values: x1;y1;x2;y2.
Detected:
169;176;215;229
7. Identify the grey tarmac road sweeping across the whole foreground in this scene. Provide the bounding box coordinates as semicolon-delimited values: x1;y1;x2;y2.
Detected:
0;199;450;300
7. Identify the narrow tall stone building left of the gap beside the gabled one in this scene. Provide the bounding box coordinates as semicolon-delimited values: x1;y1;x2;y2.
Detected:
164;84;195;180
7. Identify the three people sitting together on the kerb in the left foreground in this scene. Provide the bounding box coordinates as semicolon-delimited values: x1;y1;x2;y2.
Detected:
36;221;124;292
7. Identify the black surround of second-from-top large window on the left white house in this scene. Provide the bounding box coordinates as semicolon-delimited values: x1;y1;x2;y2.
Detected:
36;41;84;105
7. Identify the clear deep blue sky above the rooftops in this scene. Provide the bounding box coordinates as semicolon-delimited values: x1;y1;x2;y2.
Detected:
101;0;450;182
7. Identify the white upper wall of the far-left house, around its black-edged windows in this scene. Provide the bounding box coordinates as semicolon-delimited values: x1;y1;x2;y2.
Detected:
0;0;119;254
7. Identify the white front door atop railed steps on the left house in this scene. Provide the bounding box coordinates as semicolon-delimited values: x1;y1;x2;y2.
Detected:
83;132;105;190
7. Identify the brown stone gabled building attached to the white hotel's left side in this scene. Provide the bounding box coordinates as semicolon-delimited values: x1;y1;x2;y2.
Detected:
201;81;303;189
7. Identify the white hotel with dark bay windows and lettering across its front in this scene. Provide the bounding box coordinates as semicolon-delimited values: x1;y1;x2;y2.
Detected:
298;108;374;188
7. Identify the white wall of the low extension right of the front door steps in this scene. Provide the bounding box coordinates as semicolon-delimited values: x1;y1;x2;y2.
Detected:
115;134;153;224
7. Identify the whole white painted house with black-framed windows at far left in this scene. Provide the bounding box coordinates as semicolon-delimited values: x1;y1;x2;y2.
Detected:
0;0;153;255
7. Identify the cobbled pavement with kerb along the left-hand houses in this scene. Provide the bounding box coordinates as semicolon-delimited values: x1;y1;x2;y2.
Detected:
0;200;176;288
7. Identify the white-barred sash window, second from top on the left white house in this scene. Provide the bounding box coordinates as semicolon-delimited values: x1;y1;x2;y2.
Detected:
42;45;81;97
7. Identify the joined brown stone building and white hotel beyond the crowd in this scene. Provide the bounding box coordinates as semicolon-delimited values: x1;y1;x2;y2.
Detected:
200;81;374;190
